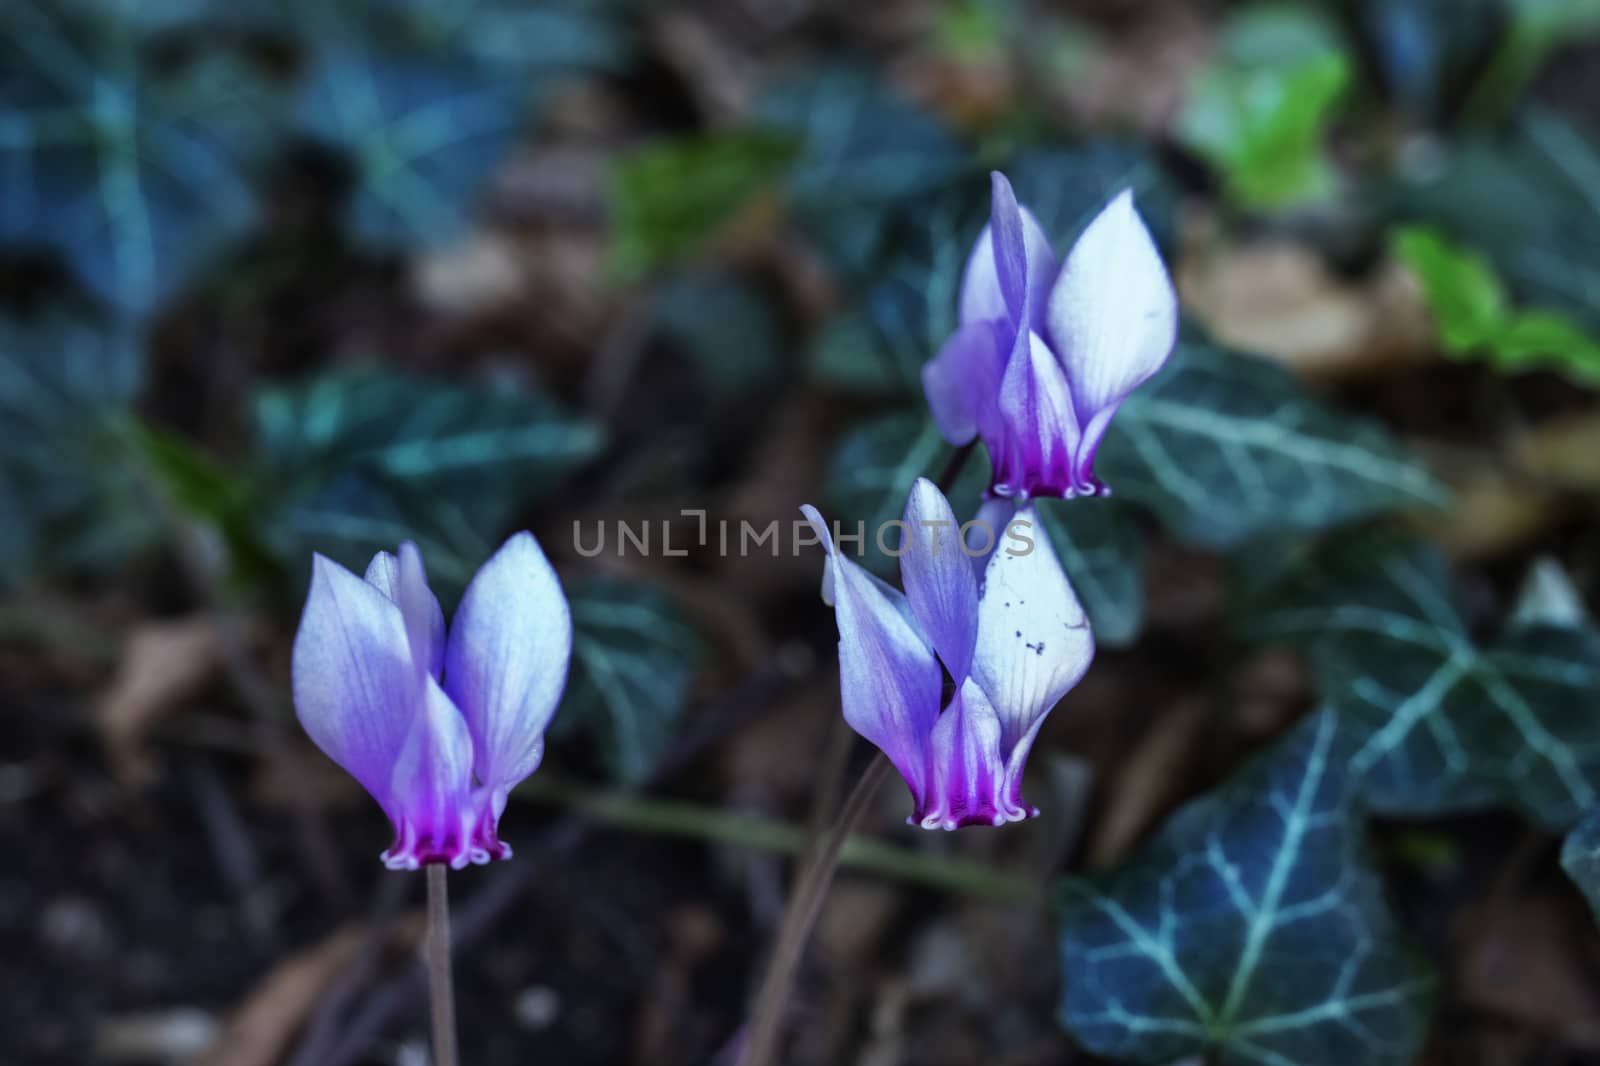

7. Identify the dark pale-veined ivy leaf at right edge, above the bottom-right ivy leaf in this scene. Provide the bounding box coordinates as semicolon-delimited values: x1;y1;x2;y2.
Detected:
1246;541;1600;831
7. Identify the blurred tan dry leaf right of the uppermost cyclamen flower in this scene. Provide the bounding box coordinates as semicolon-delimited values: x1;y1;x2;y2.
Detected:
1178;230;1434;378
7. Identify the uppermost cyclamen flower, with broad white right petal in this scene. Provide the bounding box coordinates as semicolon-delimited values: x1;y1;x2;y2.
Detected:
922;171;1178;499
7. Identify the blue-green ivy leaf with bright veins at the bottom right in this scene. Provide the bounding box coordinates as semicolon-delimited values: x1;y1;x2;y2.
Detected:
1061;714;1435;1066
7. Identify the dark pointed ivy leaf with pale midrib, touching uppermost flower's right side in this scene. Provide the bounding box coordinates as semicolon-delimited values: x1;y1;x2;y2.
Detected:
1096;338;1445;547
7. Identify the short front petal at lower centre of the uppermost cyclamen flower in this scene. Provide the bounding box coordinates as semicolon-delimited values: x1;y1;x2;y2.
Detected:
989;333;1091;498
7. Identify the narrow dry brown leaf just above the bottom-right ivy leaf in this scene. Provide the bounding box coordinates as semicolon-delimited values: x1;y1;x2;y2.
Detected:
1088;699;1208;869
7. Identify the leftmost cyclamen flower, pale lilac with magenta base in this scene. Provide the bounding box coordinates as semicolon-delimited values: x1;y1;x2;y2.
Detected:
294;533;573;869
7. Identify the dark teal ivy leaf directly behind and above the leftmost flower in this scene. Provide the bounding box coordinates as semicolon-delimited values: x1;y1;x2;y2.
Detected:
254;370;605;587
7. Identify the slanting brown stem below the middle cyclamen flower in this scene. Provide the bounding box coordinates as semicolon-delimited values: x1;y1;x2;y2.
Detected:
739;745;890;1066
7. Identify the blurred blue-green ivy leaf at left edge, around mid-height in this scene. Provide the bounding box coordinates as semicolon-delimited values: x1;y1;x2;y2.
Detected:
0;309;155;578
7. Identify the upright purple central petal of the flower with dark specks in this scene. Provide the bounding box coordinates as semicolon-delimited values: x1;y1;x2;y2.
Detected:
901;477;978;680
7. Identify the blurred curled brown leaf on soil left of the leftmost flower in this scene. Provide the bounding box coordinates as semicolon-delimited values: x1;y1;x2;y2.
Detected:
94;615;222;784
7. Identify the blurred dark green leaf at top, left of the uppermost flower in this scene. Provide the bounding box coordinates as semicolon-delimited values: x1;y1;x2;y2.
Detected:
606;130;800;279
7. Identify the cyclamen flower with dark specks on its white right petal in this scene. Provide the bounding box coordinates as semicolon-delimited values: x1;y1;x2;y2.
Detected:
802;479;1094;829
